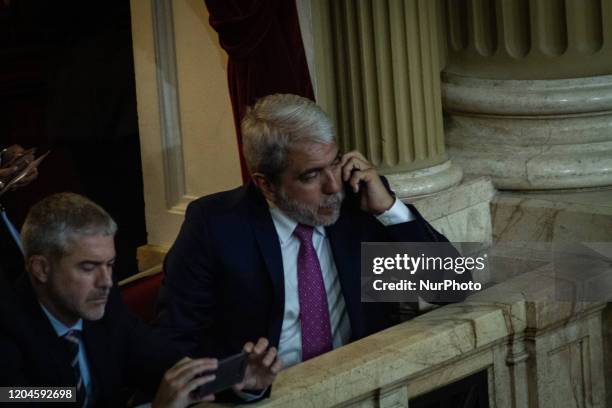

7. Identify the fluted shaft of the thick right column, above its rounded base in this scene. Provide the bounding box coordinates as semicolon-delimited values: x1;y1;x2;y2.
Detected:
442;0;612;79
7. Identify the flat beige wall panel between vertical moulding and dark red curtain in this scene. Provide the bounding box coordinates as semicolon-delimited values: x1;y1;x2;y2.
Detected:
173;0;242;196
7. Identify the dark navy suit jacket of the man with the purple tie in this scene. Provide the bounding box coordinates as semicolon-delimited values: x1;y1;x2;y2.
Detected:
157;184;460;357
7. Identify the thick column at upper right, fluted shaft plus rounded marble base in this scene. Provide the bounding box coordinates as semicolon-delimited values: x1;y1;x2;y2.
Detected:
440;0;612;190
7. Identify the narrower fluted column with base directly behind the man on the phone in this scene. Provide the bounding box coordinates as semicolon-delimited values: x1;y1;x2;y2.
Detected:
313;0;462;197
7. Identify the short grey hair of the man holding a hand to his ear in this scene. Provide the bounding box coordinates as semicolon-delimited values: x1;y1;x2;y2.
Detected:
240;94;335;181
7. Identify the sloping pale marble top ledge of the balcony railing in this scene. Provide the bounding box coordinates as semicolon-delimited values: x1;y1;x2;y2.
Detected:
225;306;522;407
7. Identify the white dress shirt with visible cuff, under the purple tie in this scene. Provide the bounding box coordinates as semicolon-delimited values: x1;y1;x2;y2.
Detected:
270;199;414;367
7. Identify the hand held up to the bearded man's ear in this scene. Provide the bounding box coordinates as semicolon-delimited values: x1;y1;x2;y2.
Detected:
340;151;395;215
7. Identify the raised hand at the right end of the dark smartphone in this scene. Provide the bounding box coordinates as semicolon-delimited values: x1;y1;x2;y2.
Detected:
234;337;283;391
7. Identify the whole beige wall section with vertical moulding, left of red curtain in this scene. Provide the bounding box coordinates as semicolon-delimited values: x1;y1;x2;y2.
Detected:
131;0;242;246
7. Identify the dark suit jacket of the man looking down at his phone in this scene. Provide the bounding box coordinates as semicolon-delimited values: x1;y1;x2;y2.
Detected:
0;276;179;407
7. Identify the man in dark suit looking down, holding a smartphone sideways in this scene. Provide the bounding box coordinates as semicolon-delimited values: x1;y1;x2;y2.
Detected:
0;193;278;407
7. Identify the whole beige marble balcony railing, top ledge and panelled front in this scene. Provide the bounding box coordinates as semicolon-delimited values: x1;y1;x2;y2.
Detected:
202;266;606;408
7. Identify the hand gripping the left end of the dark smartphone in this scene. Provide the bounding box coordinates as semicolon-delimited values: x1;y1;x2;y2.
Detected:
152;357;218;408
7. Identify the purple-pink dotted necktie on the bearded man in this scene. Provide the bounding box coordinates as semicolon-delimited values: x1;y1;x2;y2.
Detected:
293;224;332;361
